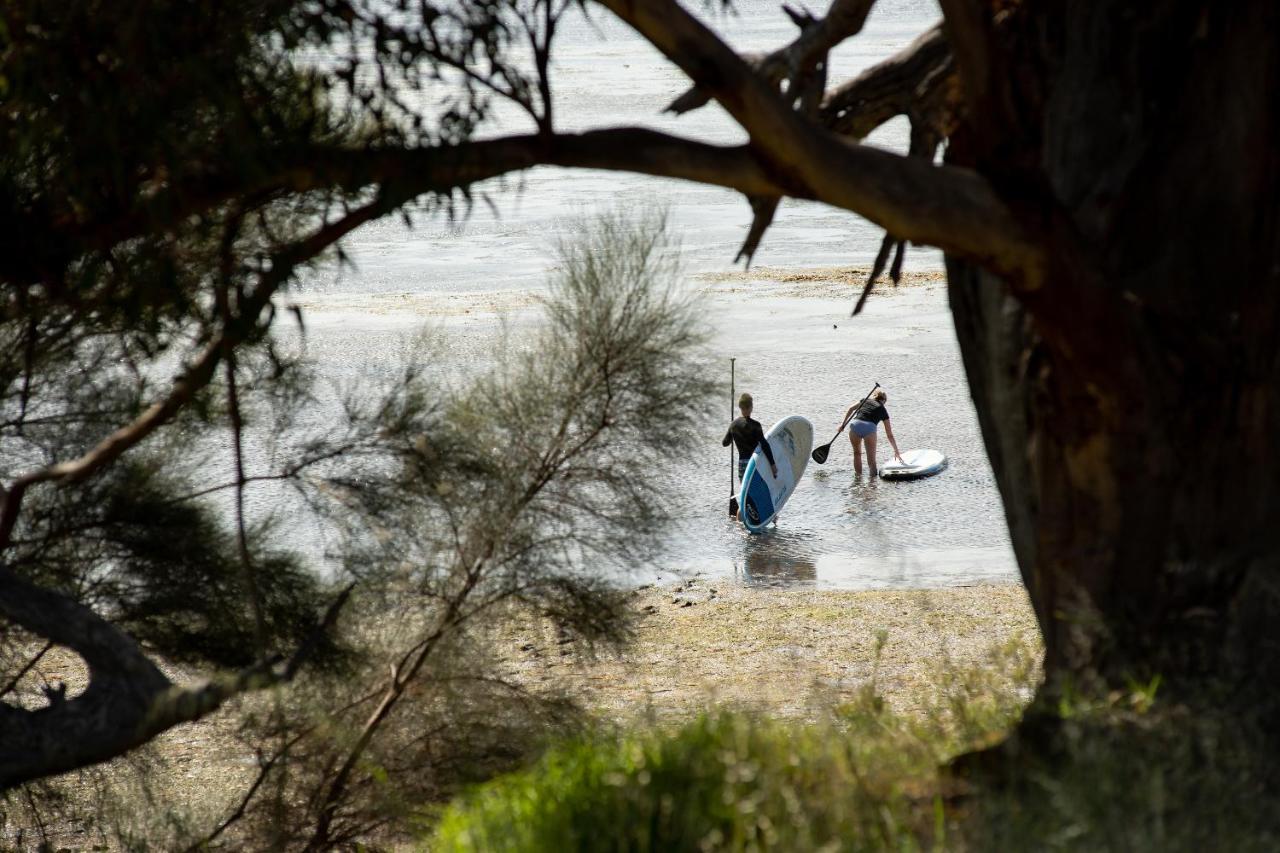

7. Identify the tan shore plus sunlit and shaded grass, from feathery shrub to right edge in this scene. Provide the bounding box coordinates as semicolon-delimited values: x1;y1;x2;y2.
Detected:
437;581;1280;853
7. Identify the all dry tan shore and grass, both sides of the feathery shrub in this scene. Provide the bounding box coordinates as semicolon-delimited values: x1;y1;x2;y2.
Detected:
20;578;1280;852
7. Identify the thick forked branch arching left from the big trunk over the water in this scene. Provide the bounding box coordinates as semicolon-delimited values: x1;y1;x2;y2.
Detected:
7;82;1038;289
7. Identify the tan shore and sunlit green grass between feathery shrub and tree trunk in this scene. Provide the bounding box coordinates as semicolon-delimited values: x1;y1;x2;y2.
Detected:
440;580;1042;853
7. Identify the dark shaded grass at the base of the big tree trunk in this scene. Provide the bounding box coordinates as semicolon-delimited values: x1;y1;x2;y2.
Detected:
968;685;1280;853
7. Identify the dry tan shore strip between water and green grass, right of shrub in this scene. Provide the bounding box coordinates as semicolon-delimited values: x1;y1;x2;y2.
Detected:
504;580;1041;722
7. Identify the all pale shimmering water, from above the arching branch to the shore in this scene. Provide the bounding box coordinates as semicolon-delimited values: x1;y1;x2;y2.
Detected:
280;0;1018;588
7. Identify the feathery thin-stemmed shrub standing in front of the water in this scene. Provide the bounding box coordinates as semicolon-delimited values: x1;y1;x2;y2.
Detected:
218;207;710;847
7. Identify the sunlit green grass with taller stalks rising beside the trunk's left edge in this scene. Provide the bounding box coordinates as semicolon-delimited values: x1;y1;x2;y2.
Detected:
431;627;1038;852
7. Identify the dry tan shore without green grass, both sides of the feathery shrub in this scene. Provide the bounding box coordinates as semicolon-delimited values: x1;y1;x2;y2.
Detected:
4;578;1039;849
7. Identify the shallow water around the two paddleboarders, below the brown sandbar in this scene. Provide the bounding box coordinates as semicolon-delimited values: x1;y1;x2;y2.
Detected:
669;281;1016;587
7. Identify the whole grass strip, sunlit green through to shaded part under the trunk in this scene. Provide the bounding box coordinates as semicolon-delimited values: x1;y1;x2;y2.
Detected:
426;640;1280;853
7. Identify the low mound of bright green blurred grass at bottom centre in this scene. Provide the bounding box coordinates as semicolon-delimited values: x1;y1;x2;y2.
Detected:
433;713;943;850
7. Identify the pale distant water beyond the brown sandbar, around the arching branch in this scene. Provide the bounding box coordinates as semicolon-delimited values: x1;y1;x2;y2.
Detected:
296;0;941;295
